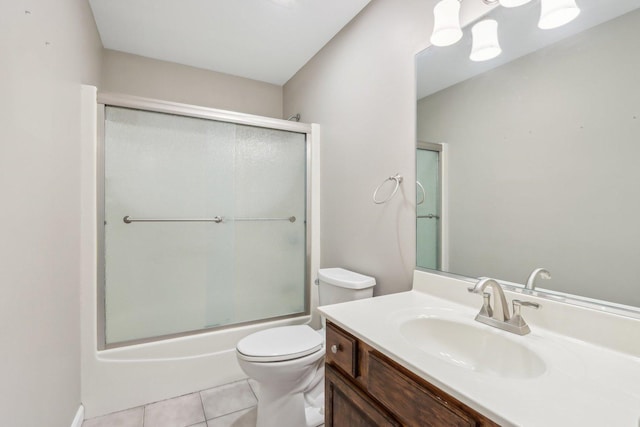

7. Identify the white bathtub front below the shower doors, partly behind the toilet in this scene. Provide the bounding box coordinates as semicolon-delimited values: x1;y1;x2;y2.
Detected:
82;316;310;418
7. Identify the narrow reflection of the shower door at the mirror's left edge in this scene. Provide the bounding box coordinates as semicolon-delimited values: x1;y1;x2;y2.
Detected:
416;142;442;269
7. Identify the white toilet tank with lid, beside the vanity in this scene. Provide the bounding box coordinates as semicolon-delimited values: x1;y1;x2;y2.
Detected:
318;268;376;305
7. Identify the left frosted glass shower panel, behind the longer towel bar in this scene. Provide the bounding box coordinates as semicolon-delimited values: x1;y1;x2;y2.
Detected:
105;107;235;343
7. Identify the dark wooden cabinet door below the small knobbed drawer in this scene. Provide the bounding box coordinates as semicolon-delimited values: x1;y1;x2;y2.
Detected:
325;365;400;427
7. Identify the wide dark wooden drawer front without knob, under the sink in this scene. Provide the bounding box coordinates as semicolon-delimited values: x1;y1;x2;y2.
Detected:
367;351;477;427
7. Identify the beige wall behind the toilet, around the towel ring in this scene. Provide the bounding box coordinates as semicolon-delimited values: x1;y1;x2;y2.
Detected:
284;0;433;294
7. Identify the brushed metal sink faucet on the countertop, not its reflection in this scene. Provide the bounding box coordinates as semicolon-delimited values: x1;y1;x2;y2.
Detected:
468;277;540;335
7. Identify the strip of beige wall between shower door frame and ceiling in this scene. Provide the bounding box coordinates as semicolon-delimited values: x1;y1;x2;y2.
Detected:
101;49;282;119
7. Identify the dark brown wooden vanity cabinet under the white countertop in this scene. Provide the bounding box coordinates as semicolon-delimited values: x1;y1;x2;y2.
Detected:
325;322;498;427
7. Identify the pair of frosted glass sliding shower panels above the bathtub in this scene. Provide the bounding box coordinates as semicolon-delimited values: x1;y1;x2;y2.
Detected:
104;107;307;345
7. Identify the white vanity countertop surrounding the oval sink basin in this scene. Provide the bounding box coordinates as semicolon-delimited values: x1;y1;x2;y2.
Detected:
319;270;640;427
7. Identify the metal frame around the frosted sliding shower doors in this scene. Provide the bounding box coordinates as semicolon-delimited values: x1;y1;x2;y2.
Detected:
96;92;319;350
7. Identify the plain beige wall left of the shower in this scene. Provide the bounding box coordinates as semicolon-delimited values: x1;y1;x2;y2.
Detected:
0;0;102;427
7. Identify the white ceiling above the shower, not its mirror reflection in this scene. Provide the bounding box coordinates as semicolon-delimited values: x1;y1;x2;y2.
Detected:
89;0;370;85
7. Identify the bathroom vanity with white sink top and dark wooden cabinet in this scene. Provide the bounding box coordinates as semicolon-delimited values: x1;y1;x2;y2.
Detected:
319;271;640;427
